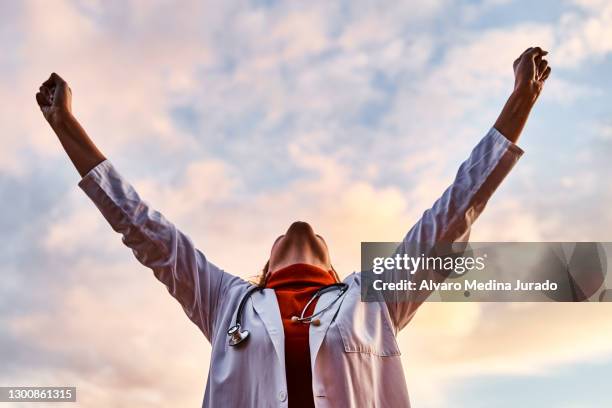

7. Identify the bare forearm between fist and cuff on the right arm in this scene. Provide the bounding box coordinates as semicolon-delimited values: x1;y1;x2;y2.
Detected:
494;89;538;143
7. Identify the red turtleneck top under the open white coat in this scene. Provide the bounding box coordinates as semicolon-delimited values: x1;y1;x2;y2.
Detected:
266;264;335;408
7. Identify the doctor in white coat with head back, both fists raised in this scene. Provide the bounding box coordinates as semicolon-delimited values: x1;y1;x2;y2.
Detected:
36;47;550;408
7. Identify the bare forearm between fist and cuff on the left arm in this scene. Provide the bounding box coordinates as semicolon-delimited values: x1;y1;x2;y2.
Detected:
51;114;106;177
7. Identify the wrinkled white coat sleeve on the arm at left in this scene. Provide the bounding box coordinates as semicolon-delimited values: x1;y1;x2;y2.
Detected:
79;160;239;340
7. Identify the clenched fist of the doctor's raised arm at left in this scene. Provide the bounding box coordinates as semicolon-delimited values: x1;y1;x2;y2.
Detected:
36;72;72;124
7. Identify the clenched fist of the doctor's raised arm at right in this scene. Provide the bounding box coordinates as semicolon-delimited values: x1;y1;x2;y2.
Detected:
513;47;551;96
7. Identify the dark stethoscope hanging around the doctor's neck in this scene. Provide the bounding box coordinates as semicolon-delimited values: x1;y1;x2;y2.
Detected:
227;283;348;346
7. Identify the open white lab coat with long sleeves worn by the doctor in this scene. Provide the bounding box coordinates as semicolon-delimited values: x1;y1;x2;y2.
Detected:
79;129;522;408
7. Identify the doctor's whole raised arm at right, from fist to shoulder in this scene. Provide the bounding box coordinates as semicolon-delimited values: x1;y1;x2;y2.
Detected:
385;47;551;330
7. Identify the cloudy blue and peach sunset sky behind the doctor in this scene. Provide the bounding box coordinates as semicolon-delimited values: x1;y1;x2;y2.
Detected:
0;0;612;408
